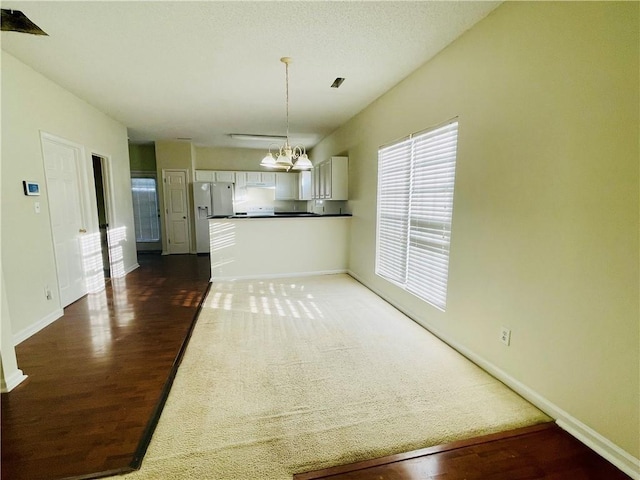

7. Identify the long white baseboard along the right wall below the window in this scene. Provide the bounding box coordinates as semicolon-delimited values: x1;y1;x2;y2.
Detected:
347;271;640;480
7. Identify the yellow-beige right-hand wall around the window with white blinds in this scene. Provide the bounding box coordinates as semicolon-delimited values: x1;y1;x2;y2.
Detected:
313;2;640;460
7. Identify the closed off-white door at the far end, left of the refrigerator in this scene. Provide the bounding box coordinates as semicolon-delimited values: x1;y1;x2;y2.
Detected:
162;170;190;254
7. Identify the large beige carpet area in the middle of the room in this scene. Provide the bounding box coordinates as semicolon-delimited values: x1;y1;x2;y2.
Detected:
110;275;550;480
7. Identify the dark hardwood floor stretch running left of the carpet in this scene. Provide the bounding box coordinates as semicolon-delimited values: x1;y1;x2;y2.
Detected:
2;254;210;480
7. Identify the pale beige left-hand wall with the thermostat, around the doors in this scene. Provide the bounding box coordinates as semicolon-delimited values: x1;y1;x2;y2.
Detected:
1;52;137;342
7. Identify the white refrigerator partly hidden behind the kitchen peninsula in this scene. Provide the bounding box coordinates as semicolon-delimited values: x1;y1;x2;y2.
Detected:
193;182;234;253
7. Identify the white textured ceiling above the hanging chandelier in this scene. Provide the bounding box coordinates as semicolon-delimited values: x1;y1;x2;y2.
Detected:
1;1;501;148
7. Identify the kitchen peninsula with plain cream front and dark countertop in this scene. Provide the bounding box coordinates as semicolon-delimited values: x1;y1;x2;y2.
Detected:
209;213;351;281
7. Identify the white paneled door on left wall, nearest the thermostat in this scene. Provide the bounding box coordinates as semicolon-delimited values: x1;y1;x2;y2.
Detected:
42;134;87;307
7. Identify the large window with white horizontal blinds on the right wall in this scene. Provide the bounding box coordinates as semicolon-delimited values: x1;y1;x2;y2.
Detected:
376;121;458;310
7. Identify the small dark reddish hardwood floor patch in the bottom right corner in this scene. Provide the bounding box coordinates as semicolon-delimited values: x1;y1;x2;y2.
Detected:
293;422;630;480
